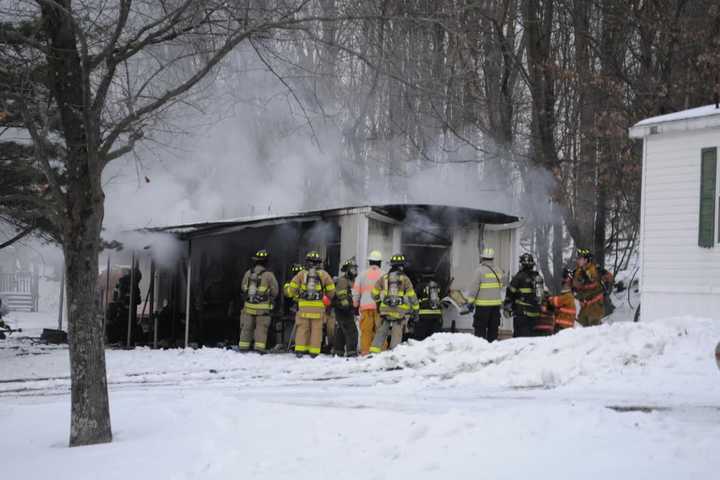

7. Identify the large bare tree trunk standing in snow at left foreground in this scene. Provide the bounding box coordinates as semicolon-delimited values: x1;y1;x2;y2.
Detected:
42;0;112;446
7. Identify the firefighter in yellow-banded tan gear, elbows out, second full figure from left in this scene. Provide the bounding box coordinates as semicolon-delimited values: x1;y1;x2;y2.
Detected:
288;251;335;357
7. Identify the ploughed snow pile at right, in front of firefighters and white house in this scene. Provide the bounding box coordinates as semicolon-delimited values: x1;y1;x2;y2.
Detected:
338;318;720;388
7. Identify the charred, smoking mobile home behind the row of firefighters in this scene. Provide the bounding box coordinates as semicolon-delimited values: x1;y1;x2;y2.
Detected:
129;204;520;346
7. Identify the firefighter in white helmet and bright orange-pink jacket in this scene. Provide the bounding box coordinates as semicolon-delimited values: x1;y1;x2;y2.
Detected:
353;250;382;355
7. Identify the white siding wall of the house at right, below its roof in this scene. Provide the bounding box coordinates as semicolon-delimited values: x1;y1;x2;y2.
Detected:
640;128;720;321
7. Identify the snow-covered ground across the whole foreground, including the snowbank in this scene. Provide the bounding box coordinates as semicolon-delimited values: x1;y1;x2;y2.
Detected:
0;307;720;480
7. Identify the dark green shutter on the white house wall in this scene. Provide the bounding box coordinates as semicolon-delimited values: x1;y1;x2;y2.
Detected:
698;148;720;248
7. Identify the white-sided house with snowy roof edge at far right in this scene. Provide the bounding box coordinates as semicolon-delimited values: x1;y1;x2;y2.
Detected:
630;105;720;320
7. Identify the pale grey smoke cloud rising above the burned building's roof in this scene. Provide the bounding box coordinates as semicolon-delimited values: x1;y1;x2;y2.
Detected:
98;48;554;236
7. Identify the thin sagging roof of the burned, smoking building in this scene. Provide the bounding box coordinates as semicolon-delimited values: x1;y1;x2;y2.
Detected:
144;204;520;238
